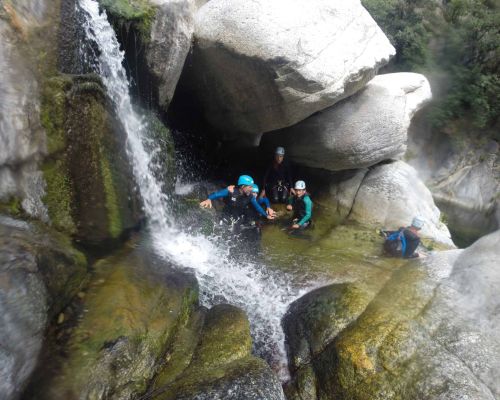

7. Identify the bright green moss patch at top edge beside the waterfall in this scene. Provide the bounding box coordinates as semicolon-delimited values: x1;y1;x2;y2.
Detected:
99;0;156;43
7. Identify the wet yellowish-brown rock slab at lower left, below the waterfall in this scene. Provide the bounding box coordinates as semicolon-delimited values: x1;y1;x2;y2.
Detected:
36;244;198;400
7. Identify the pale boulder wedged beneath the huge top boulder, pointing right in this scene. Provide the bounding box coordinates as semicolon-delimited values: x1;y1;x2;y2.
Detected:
262;73;432;171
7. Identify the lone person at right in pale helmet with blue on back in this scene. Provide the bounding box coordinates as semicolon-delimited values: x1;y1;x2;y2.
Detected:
381;217;424;258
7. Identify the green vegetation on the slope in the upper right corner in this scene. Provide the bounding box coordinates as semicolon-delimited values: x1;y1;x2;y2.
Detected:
362;0;500;140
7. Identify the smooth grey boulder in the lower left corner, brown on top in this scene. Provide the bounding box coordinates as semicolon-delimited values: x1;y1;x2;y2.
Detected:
0;216;87;400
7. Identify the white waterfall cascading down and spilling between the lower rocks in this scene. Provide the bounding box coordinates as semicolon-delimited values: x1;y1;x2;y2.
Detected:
79;0;312;379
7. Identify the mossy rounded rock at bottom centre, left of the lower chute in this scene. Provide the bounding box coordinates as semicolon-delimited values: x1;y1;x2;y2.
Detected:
151;304;284;400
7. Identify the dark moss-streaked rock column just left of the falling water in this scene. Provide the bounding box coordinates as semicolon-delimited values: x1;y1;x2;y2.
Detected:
41;75;141;245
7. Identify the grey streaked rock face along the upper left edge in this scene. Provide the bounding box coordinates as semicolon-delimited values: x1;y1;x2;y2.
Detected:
0;0;51;218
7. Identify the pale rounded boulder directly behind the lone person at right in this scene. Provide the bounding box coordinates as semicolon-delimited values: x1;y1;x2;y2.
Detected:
348;161;453;246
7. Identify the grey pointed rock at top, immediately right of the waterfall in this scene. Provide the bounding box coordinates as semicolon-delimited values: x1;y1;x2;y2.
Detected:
99;0;197;111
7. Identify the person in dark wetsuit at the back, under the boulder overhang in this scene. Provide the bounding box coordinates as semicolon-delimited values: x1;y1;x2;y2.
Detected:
260;147;293;203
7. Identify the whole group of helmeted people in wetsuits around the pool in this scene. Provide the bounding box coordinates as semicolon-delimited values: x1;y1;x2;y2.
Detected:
200;146;424;258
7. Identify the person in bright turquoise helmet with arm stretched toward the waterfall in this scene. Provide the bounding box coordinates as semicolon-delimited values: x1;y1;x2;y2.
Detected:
200;175;274;224
